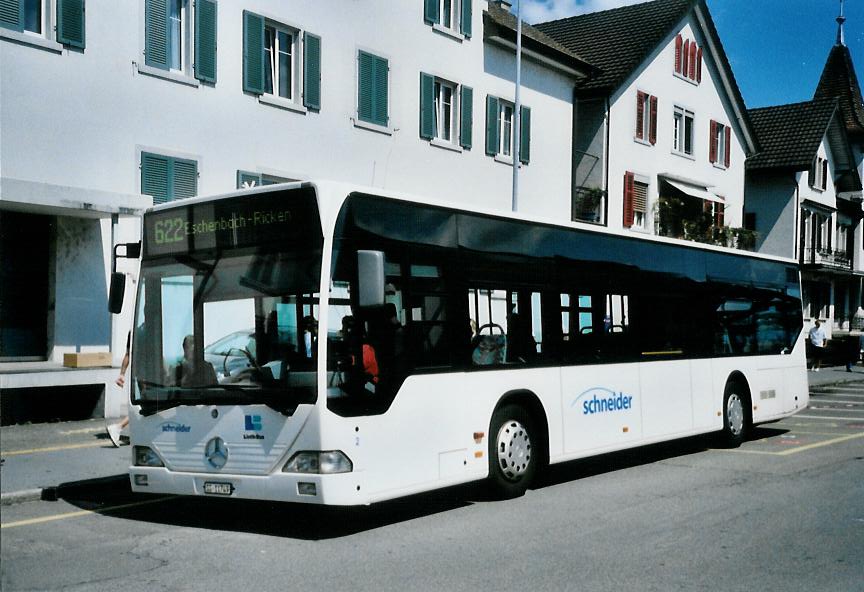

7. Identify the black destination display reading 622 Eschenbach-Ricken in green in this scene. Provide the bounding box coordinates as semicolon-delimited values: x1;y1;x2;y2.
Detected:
144;188;321;257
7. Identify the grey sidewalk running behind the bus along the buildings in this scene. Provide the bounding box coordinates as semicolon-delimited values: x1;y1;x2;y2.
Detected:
0;366;864;505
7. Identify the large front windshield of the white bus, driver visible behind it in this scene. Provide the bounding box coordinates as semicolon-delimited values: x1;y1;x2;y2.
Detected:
132;187;323;414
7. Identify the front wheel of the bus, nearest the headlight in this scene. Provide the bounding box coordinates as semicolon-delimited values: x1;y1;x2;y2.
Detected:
489;405;540;499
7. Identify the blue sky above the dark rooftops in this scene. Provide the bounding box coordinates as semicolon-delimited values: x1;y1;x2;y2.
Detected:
514;0;864;108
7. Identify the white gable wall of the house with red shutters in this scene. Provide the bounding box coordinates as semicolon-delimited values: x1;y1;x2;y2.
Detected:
609;17;746;231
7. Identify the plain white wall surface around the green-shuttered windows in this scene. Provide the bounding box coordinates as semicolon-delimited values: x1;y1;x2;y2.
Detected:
0;0;574;216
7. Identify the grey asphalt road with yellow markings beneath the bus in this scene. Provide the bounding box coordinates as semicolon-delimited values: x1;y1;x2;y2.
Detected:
0;383;864;592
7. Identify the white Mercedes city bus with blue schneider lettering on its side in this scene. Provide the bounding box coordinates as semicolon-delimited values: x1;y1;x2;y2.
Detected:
112;182;808;505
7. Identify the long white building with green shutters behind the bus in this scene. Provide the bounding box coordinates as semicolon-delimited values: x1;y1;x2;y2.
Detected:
0;0;589;416
